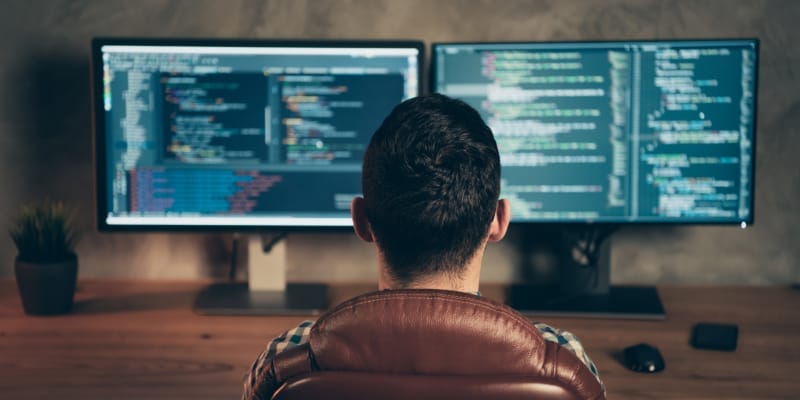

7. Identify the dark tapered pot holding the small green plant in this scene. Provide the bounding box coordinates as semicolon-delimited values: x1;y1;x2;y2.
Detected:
14;256;78;315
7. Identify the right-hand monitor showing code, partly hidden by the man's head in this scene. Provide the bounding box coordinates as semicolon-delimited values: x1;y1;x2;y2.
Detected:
431;39;758;226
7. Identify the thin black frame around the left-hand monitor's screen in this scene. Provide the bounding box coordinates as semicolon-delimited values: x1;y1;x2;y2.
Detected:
89;37;427;232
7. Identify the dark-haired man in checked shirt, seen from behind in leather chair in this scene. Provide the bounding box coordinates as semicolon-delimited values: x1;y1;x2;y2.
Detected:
243;94;599;400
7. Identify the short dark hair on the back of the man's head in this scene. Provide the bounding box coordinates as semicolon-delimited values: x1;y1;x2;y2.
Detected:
362;94;500;286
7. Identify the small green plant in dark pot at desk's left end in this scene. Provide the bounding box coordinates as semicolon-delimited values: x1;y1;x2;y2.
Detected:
9;202;78;315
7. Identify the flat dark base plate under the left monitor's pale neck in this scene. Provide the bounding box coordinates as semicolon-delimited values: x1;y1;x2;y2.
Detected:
194;282;330;315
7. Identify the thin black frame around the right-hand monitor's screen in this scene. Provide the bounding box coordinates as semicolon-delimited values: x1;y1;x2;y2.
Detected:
428;37;761;229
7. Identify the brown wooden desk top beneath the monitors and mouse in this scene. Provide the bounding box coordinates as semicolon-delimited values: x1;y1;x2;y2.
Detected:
0;280;800;400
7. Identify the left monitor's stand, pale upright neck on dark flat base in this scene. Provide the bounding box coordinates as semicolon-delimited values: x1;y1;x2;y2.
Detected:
194;235;329;315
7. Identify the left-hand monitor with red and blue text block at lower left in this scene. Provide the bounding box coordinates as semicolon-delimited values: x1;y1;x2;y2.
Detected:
92;39;424;230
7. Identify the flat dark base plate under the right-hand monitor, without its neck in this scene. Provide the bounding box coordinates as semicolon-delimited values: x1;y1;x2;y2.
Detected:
506;285;666;320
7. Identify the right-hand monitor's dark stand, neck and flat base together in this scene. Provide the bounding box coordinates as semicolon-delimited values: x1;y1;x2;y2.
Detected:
506;240;666;320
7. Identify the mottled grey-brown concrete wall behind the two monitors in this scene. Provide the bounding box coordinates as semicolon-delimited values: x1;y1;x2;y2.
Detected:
0;0;800;284
